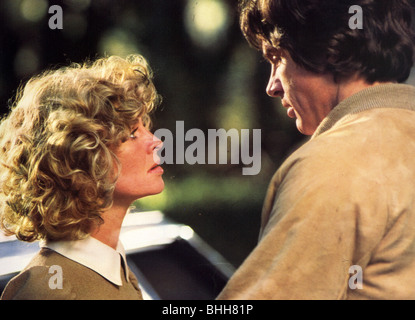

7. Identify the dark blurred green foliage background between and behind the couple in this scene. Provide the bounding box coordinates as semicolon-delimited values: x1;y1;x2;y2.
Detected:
0;0;412;267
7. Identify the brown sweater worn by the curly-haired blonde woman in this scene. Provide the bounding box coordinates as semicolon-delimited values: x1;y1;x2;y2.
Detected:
1;248;142;300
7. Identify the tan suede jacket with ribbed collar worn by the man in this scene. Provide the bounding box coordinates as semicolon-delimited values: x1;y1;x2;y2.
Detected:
218;84;415;299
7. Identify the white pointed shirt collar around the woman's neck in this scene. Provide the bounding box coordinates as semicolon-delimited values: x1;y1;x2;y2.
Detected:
40;237;129;286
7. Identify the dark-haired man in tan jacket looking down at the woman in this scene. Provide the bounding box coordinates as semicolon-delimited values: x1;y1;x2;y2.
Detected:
218;0;415;299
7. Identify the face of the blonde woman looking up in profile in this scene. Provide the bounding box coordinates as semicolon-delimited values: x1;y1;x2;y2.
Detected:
114;119;164;204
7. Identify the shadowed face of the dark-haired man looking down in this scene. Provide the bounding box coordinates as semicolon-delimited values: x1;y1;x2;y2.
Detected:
262;42;339;135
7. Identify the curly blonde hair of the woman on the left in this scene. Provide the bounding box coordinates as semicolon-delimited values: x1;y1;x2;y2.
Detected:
0;55;160;241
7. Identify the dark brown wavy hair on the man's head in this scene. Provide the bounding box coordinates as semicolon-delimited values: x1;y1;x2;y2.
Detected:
240;0;415;83
